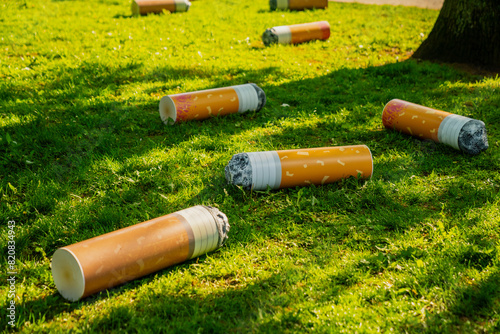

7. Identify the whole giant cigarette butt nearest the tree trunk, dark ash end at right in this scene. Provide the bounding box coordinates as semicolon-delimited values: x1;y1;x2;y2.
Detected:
382;99;488;155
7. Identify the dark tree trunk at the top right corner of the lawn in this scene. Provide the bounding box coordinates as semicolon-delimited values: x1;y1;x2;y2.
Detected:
413;0;500;68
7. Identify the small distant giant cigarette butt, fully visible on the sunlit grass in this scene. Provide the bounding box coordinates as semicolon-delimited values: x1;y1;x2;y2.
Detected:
262;21;330;46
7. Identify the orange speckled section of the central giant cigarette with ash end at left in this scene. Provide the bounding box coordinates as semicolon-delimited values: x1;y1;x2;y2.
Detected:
277;145;373;188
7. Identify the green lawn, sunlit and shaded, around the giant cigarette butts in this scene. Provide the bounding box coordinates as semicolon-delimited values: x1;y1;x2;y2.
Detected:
0;0;500;333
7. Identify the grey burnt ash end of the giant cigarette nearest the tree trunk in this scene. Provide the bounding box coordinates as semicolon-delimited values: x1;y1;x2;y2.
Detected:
458;119;488;155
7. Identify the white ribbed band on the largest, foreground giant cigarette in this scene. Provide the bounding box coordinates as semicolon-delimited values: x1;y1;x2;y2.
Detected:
176;205;219;258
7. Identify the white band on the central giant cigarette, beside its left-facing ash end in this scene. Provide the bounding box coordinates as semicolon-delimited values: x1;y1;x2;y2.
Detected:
247;151;281;190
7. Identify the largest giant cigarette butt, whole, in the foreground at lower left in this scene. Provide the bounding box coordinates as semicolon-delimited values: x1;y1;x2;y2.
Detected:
52;205;229;301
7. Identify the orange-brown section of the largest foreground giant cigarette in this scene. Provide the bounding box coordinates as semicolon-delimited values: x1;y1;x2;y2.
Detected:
63;214;189;298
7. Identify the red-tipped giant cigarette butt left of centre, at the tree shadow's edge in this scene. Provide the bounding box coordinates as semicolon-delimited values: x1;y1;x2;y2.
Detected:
160;84;266;124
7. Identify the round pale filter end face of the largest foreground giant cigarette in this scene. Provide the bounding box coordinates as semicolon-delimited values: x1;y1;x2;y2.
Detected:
51;248;85;302
